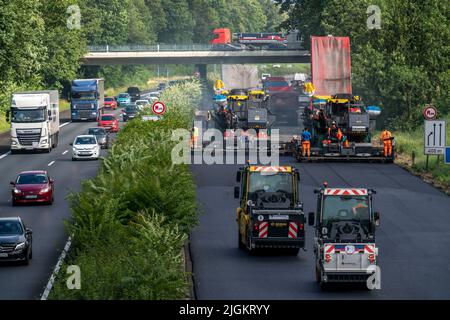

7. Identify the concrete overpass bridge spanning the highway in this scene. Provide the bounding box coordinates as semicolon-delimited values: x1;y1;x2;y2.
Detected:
82;45;311;66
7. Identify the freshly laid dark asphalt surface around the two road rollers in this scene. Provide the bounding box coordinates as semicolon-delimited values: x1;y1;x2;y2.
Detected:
191;157;450;299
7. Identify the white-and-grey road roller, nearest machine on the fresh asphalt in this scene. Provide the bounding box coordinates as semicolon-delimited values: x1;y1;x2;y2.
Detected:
308;183;380;287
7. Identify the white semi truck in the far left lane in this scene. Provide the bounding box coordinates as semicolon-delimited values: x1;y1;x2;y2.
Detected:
6;90;59;153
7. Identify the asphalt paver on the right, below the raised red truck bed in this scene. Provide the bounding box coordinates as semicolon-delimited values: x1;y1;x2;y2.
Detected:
293;94;394;162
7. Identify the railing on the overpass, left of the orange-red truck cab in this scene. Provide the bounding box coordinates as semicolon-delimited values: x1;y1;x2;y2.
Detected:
88;44;212;52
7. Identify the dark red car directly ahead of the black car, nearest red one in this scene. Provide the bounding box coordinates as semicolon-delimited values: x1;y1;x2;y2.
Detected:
11;171;54;206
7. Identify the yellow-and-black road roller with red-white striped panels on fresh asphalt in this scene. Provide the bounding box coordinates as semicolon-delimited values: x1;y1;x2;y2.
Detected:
234;165;305;255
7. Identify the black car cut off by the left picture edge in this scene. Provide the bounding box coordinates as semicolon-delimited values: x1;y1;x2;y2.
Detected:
0;217;33;265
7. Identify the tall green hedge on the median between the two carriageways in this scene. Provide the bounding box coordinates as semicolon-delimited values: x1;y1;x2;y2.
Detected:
50;82;201;299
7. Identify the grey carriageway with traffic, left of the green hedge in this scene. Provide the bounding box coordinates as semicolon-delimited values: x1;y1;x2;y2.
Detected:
0;111;118;299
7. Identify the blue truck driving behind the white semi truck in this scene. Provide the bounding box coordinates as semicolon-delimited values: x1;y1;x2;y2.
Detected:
70;79;105;121
